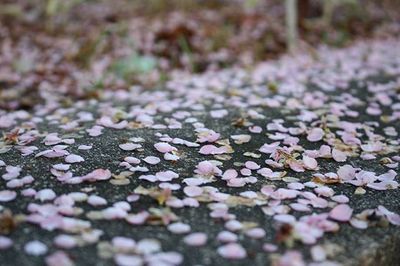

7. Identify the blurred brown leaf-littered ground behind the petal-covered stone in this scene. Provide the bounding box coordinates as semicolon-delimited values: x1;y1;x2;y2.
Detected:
0;0;400;110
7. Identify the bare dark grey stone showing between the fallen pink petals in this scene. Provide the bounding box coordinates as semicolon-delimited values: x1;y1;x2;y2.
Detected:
0;39;400;266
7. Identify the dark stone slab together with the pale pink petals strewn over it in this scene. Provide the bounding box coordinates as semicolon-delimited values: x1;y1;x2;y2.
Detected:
0;39;400;265
